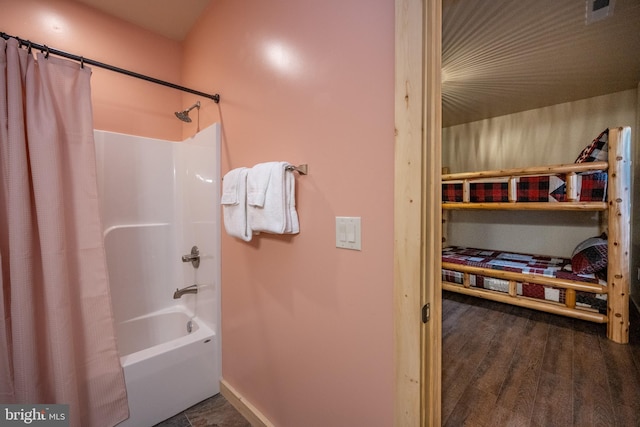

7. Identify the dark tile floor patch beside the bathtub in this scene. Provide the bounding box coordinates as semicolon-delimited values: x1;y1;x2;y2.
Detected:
155;394;251;427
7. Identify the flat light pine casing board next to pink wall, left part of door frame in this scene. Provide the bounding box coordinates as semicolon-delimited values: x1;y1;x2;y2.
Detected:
393;0;423;427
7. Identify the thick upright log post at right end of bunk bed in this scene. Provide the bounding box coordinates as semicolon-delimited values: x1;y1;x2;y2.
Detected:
607;127;631;344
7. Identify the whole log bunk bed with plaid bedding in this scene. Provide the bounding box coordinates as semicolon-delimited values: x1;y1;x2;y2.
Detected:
442;127;631;343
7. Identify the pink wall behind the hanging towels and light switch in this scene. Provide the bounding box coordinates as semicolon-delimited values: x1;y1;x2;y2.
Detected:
183;0;394;427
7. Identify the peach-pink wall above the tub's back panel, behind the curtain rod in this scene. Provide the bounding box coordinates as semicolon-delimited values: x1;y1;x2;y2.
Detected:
0;0;184;140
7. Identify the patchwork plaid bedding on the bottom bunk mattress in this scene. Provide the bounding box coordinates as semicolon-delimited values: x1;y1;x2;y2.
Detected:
442;246;607;314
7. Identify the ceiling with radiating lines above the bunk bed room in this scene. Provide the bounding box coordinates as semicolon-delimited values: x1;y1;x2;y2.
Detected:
442;0;640;127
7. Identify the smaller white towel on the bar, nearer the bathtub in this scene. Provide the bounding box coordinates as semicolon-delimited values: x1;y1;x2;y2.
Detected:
220;168;252;242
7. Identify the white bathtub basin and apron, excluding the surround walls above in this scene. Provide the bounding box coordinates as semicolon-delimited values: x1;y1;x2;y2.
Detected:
116;306;220;427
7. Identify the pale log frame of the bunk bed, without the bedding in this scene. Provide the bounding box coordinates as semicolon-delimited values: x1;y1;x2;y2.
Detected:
442;127;631;344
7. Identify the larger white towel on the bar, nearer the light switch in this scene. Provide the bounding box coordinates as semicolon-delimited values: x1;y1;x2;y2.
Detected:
247;162;300;234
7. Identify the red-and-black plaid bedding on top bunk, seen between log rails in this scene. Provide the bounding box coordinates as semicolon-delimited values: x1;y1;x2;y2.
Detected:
442;172;607;203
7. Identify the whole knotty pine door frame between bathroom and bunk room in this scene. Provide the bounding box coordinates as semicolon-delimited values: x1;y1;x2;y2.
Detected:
394;0;442;427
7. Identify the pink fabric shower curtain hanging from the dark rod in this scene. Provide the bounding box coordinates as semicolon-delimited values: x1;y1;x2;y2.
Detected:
0;39;129;427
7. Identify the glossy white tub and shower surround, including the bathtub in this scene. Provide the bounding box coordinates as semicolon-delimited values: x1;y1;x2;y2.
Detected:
95;125;221;427
